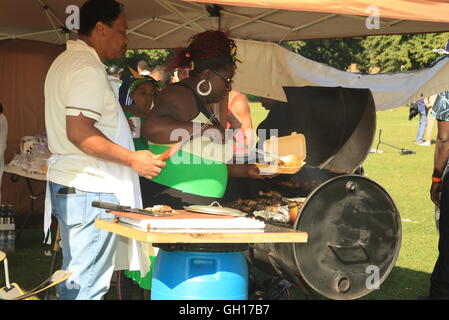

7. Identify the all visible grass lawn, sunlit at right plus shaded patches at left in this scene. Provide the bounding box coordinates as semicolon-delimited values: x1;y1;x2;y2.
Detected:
0;103;438;300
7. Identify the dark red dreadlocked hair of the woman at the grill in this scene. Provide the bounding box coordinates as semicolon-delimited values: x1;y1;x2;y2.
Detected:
168;30;236;69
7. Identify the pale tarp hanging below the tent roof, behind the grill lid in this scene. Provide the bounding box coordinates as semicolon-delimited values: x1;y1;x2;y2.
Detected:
234;40;449;110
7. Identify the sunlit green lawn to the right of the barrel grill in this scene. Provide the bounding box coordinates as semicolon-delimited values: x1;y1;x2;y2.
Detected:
363;107;438;299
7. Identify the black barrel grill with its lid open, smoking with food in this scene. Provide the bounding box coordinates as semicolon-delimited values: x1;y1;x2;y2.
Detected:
223;87;402;300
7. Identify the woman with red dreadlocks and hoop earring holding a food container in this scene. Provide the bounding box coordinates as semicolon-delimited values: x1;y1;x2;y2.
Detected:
142;31;267;209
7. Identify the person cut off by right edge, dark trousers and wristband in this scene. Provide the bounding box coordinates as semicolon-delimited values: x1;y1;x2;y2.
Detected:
426;91;449;300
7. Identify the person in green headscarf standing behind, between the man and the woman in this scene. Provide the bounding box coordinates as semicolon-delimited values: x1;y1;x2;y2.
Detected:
119;76;162;298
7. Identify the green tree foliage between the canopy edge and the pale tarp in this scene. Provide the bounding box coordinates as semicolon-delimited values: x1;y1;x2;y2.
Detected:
283;33;449;72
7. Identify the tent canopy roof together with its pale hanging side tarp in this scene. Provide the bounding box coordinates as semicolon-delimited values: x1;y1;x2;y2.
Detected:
0;0;449;109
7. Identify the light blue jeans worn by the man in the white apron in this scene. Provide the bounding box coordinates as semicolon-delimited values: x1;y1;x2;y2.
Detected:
50;182;118;300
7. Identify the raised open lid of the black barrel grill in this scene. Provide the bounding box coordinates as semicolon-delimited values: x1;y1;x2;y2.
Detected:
284;87;376;173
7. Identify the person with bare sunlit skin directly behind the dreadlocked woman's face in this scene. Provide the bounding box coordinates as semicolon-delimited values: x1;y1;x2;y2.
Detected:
226;90;254;154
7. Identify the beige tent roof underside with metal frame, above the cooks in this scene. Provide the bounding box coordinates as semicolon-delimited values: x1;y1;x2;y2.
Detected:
0;0;449;49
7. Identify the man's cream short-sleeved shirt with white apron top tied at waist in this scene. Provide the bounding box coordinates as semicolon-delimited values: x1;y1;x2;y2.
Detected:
45;40;120;192
